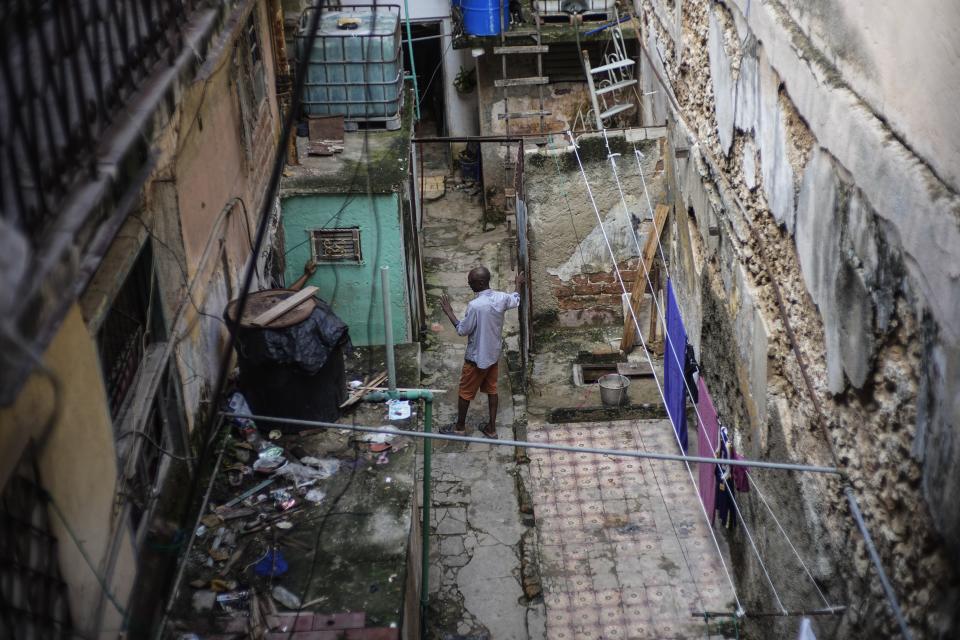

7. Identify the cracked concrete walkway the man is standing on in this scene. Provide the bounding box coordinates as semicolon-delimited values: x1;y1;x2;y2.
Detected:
421;185;546;640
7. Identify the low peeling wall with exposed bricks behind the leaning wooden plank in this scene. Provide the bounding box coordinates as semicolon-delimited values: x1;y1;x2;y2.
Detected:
524;130;664;326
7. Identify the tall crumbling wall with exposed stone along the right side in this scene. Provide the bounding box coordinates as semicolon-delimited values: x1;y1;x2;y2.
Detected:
637;0;960;638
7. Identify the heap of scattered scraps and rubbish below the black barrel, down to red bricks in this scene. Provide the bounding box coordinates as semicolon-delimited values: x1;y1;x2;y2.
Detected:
173;393;408;638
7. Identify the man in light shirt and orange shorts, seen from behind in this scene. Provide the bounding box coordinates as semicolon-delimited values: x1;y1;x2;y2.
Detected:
440;267;525;440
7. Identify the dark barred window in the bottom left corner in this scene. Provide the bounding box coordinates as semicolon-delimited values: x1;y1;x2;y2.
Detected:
0;449;74;640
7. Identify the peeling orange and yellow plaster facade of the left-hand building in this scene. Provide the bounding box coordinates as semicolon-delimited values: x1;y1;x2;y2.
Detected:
0;0;279;636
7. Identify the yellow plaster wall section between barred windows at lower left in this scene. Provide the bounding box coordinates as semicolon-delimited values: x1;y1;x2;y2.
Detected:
0;305;136;635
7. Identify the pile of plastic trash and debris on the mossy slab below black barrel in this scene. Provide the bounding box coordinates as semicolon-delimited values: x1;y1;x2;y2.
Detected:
176;393;409;637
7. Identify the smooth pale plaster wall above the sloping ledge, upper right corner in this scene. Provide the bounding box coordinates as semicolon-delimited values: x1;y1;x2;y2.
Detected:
752;0;960;198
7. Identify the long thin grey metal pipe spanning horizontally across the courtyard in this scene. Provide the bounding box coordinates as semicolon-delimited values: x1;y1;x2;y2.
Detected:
221;412;844;475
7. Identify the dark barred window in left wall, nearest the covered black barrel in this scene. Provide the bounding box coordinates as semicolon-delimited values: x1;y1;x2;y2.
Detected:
97;241;166;419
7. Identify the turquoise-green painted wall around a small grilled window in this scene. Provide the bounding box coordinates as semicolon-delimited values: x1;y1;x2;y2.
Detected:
281;193;410;345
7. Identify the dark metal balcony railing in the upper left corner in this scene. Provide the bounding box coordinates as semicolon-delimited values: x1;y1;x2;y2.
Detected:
0;0;199;238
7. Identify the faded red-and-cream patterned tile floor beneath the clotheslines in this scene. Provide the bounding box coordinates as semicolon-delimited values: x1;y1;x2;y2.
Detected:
528;420;733;640
